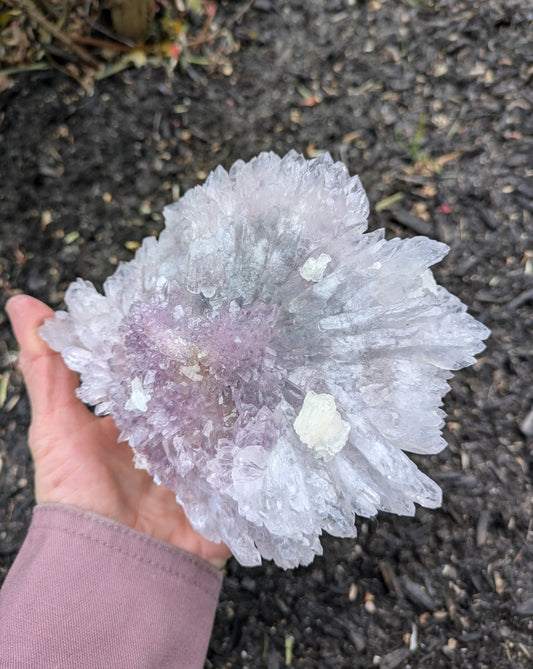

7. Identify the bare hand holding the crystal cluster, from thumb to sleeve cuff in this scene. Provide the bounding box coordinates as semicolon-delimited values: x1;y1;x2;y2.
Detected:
6;295;231;568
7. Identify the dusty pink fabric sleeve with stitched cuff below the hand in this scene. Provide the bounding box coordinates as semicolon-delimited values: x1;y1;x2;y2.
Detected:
0;504;222;669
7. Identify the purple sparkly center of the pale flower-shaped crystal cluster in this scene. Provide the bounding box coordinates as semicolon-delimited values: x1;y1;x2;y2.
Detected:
122;295;279;447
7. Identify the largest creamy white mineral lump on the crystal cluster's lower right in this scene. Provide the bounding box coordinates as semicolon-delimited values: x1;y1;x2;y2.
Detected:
294;390;350;460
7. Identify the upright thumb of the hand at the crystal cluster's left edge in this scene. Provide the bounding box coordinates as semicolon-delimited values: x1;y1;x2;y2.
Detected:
6;295;87;420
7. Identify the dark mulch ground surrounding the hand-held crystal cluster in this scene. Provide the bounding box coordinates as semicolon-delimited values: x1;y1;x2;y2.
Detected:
0;0;533;669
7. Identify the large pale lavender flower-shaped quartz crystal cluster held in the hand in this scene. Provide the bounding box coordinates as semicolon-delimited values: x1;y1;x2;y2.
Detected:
40;152;489;568
